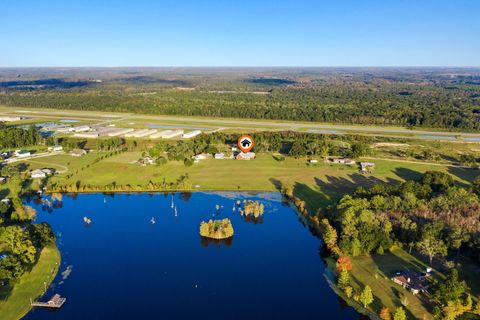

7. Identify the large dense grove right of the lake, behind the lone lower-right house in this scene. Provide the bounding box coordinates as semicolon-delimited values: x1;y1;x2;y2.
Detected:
325;171;480;260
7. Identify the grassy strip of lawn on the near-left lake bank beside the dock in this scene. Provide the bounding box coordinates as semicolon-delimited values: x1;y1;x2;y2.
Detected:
0;245;60;320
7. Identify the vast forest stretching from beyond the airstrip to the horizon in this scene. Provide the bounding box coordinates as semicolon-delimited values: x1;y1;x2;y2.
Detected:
0;68;480;130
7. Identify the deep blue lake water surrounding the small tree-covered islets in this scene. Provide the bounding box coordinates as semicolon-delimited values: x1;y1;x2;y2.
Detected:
22;192;360;320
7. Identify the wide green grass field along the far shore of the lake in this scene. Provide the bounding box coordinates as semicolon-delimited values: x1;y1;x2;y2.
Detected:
27;151;480;208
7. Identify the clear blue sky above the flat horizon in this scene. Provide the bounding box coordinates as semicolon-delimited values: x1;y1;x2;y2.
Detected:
0;0;480;67
